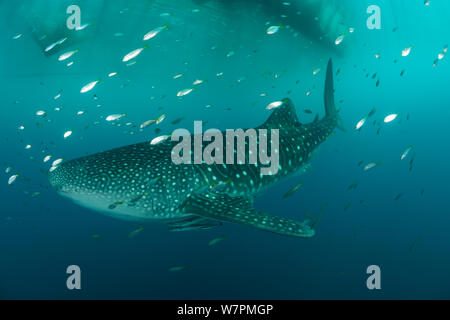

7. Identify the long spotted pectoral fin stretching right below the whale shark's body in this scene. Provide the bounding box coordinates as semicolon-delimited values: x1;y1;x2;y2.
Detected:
181;192;314;237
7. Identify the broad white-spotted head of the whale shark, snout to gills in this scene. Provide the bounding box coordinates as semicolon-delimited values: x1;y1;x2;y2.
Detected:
48;143;186;219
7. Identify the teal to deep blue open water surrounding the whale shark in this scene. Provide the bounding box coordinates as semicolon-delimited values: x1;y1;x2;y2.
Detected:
0;0;450;299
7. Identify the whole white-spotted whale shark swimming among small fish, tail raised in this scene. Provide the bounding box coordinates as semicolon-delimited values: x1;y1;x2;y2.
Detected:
49;60;341;237
